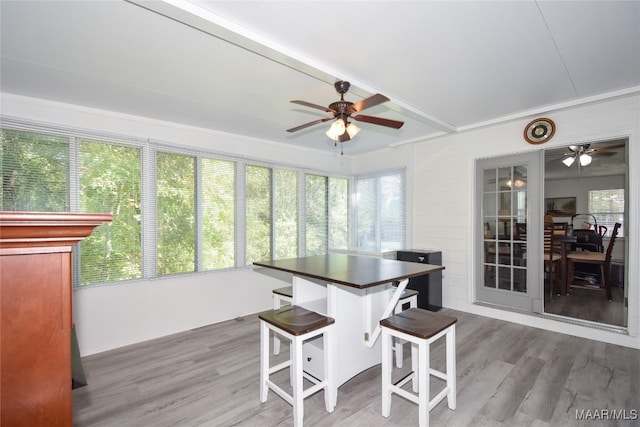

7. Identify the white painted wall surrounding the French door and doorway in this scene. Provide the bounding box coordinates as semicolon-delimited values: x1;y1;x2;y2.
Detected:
353;95;640;348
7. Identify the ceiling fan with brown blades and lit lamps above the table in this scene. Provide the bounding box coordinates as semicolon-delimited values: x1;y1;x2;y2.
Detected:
287;80;404;150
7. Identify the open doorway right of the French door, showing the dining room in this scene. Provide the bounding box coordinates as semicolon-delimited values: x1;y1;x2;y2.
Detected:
544;139;629;327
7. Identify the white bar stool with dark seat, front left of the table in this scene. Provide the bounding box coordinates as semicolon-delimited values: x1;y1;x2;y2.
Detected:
258;305;336;427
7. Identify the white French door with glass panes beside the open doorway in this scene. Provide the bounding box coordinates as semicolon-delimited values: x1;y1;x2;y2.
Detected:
475;151;544;313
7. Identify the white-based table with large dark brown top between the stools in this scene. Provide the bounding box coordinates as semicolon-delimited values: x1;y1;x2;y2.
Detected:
253;254;444;403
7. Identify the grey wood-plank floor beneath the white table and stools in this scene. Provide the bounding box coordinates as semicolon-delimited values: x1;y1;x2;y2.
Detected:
73;309;640;427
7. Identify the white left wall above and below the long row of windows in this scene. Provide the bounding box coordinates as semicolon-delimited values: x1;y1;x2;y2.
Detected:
0;94;351;356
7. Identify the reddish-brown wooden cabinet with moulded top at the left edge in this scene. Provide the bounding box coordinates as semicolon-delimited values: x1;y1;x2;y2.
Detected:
0;212;112;426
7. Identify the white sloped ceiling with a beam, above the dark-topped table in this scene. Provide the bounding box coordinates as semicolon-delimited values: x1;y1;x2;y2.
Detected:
0;0;640;155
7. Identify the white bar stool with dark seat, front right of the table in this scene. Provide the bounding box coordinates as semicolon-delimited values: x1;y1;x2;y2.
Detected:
380;308;457;426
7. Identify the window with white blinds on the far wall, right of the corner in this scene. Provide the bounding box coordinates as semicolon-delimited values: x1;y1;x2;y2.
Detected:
354;171;405;252
